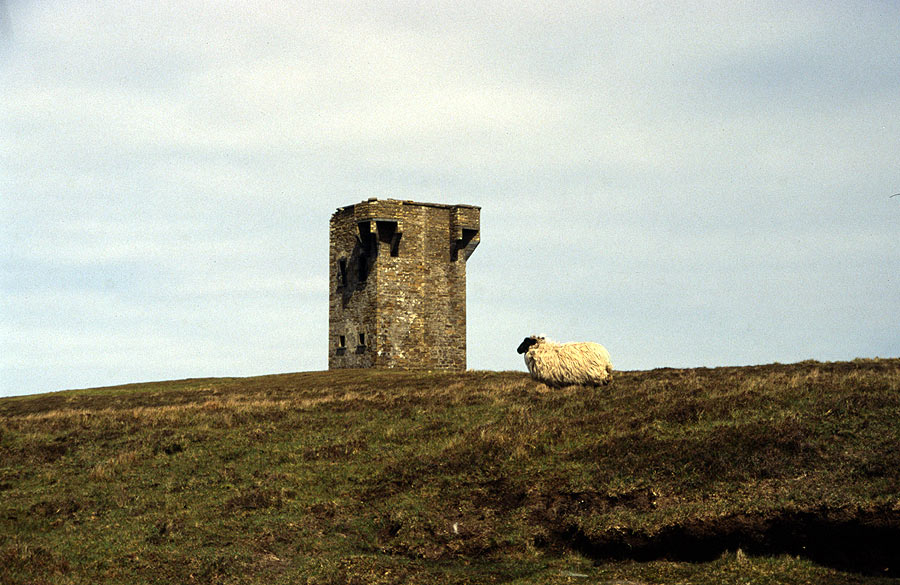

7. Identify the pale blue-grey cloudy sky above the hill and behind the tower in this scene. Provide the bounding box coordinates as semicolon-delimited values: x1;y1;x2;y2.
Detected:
0;0;900;395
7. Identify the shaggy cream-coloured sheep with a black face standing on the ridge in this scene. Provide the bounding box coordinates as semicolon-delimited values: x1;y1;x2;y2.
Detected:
516;335;612;388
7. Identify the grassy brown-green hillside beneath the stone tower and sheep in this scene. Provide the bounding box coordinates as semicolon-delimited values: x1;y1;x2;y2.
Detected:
0;359;900;585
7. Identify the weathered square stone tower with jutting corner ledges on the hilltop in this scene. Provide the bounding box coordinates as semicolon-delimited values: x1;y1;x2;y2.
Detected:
328;199;481;370
